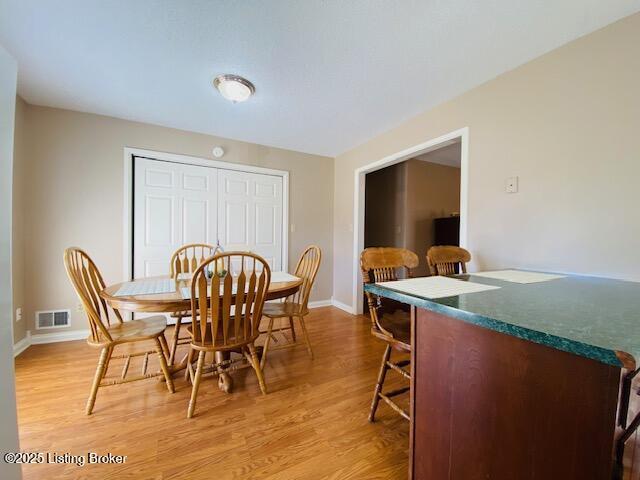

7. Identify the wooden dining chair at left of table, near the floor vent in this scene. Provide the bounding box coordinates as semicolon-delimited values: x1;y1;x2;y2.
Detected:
64;247;174;415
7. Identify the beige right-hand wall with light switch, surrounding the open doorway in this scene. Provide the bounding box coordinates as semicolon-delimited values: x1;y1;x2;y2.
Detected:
334;14;640;304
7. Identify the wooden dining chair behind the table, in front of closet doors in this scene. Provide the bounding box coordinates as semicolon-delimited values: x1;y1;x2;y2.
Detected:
169;243;219;365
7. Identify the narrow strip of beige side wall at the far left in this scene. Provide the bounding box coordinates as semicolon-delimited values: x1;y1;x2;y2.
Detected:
11;97;29;343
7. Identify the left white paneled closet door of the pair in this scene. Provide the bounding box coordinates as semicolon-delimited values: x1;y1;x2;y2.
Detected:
133;157;218;278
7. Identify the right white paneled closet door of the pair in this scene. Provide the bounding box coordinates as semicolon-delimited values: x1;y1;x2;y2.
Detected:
218;169;283;270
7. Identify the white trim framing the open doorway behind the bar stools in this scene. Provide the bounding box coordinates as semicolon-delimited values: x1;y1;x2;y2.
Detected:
351;127;469;314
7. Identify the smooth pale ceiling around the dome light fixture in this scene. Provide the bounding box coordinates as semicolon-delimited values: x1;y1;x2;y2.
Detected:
0;0;640;156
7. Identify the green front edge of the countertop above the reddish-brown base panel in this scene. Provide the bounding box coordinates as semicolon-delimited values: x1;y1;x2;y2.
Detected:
364;284;624;369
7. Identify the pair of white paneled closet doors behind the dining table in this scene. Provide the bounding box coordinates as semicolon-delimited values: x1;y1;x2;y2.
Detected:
133;157;283;278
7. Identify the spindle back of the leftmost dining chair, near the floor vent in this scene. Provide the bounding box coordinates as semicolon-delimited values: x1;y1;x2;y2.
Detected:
64;247;122;343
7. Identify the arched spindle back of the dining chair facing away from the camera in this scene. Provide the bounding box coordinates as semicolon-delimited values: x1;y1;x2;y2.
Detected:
191;252;271;348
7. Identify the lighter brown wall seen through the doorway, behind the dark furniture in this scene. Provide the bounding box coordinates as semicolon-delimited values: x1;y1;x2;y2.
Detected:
404;159;460;275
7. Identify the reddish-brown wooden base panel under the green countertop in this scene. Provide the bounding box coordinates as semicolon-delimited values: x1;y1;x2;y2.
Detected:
409;307;620;480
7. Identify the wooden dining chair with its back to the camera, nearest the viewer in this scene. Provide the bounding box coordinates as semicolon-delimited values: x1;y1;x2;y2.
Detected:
187;252;271;418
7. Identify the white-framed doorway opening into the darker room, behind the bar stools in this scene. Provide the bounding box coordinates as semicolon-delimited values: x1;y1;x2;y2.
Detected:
353;128;468;314
